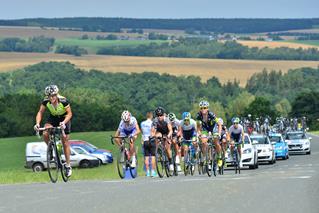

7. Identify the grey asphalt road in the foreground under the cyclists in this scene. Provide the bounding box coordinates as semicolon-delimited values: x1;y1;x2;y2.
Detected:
0;136;319;213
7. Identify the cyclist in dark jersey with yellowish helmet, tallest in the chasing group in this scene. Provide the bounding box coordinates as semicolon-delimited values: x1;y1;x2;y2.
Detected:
196;100;223;167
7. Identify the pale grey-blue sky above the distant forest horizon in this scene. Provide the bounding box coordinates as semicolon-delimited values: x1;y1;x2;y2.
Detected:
0;0;319;19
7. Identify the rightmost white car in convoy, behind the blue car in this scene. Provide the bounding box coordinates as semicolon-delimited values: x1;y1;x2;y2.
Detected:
285;131;311;155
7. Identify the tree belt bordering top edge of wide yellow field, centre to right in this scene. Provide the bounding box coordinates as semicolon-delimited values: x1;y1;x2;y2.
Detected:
97;38;319;60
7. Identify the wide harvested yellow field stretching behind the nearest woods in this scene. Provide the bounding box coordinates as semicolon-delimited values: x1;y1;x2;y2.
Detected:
0;52;319;86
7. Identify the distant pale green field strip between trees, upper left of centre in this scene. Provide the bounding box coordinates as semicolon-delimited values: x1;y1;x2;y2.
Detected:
55;38;165;54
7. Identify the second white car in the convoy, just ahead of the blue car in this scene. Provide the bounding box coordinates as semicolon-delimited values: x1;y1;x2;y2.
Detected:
250;134;276;164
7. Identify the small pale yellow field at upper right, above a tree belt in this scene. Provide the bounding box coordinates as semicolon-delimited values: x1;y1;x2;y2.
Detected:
237;41;318;49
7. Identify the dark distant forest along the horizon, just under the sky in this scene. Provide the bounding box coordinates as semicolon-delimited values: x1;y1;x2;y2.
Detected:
0;17;319;33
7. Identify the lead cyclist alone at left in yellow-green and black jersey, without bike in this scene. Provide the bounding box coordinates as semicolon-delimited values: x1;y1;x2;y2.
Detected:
34;85;72;177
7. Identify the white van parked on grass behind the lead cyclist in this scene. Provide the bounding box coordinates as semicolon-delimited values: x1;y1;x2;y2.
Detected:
25;142;100;172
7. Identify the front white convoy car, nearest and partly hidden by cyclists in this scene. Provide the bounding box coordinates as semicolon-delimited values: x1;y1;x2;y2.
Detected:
226;133;258;169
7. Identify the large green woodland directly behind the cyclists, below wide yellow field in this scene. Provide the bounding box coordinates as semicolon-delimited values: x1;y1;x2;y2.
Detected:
0;62;319;137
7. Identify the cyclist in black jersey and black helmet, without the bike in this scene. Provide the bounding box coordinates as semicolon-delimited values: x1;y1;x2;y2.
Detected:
151;107;174;171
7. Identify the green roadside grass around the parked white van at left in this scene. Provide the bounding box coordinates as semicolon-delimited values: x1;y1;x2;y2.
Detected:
0;132;145;184
